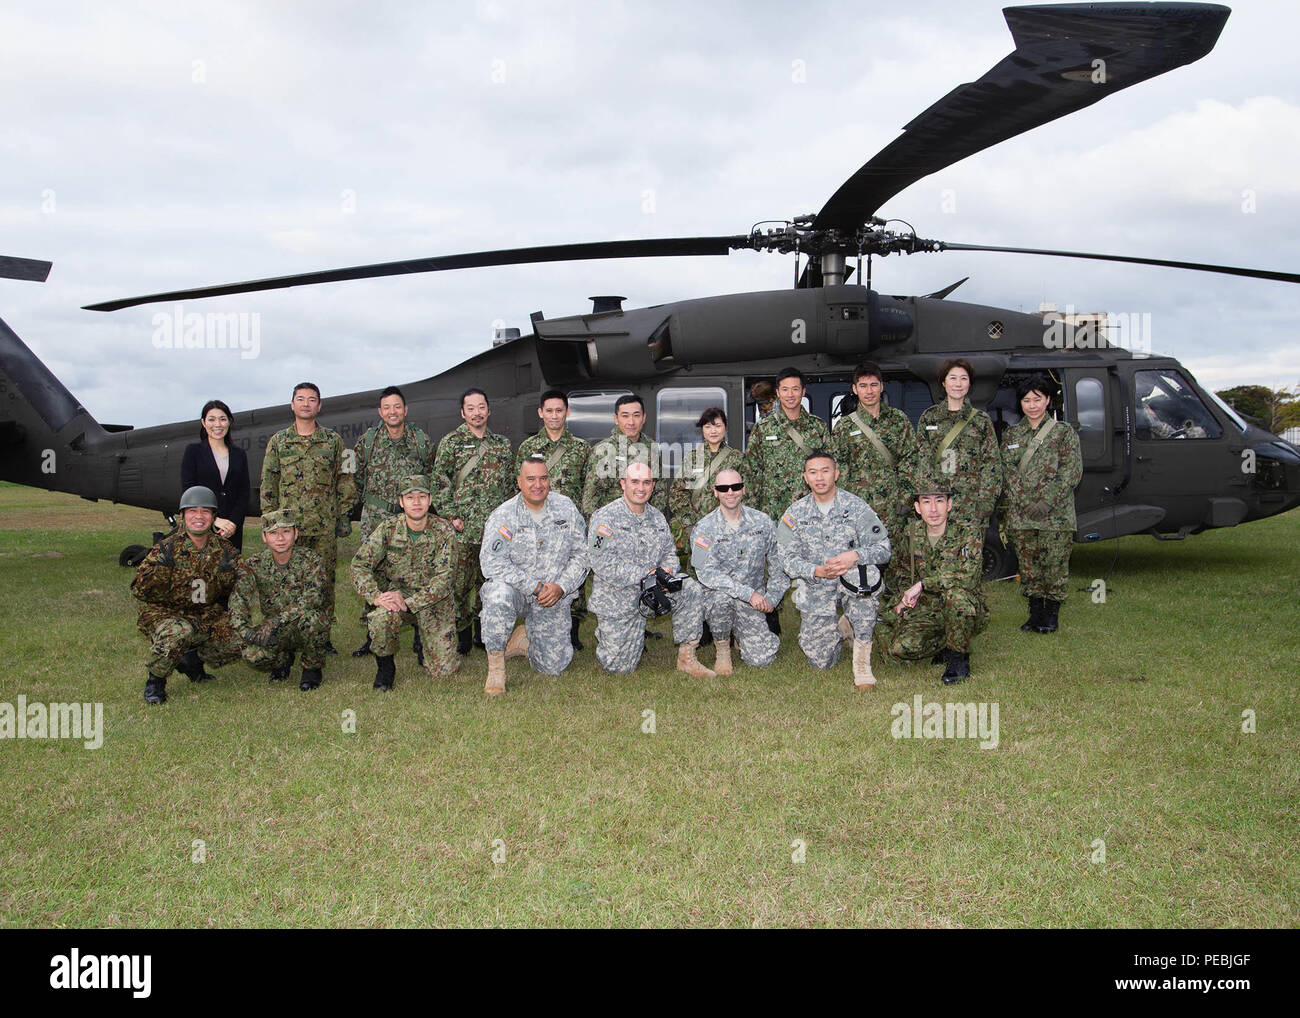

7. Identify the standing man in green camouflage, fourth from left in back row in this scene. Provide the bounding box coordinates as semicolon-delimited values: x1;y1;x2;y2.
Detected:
433;389;515;654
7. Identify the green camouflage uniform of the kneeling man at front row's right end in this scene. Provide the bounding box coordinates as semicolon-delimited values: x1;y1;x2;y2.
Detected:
876;516;988;660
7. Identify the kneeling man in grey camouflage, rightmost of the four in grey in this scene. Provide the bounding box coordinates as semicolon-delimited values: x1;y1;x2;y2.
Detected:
776;450;889;689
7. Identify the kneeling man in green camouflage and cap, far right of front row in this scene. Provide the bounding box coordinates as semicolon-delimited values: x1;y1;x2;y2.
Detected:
878;472;988;684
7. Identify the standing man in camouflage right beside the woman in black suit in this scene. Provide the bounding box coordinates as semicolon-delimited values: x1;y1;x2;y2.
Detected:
260;382;356;654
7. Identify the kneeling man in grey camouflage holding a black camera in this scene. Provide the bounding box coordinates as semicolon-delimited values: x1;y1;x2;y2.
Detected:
586;463;715;679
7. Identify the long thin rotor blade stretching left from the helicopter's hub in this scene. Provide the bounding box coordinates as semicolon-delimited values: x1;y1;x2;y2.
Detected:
85;237;749;311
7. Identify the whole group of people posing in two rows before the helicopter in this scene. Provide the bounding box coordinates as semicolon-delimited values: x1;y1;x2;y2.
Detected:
133;359;1082;703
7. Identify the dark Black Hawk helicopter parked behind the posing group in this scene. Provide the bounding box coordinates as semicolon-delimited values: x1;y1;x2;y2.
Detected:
0;4;1300;575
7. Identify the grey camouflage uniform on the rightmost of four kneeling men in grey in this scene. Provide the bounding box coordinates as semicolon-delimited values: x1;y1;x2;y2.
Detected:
776;488;889;668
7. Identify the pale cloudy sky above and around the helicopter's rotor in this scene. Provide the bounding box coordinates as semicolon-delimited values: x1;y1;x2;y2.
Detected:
0;0;1300;425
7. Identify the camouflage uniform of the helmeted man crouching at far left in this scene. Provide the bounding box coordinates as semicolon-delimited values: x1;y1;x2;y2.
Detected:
131;532;241;679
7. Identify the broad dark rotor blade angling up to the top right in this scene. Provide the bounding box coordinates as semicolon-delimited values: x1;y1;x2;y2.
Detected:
813;4;1230;233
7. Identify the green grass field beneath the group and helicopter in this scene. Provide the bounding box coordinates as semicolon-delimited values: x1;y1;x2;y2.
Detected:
0;485;1300;927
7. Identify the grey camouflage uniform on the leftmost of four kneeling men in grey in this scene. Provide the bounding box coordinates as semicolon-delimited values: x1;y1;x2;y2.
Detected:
478;491;588;675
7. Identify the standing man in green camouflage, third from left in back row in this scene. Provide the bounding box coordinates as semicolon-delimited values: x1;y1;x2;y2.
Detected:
352;385;433;658
